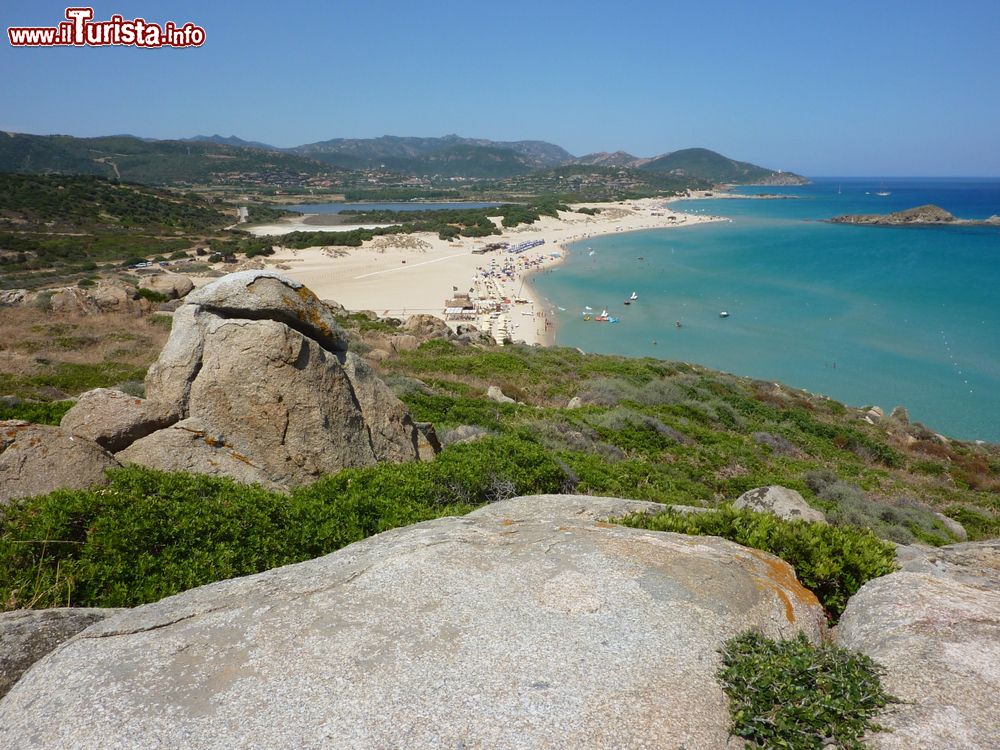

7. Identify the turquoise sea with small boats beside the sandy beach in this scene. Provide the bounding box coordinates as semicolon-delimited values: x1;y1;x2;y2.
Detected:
533;178;1000;442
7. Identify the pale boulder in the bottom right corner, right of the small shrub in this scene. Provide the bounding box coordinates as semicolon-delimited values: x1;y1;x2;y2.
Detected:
837;542;1000;750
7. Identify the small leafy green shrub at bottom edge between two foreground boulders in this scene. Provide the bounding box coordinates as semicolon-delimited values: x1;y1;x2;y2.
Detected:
716;631;896;750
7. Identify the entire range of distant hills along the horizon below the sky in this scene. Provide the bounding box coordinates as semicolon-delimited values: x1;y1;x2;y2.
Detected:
0;133;806;185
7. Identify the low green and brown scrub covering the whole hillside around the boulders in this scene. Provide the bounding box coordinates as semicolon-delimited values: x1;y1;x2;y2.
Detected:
0;320;1000;619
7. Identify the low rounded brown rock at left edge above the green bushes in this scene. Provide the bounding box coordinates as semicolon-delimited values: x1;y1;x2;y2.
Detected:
0;420;119;505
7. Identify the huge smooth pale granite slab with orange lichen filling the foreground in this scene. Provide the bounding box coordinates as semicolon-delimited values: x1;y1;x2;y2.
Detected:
0;496;824;750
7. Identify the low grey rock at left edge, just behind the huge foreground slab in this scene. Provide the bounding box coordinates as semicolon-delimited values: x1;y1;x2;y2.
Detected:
0;607;123;704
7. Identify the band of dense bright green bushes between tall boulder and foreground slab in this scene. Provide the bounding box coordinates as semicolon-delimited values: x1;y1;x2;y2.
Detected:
0;438;566;609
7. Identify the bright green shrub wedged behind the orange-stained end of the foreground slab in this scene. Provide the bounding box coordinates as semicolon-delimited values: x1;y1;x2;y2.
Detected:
620;508;896;621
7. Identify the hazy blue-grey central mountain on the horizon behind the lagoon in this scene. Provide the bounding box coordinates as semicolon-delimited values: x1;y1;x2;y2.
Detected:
289;135;573;178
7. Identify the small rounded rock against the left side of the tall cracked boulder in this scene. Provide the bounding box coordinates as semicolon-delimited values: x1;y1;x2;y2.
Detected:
60;388;171;453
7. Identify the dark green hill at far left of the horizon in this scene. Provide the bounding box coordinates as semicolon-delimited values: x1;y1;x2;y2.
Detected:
0;133;334;185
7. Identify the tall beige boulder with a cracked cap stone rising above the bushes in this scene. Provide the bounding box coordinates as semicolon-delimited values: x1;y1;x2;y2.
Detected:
117;271;418;487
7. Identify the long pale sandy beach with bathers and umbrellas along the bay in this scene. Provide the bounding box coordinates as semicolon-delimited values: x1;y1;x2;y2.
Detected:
245;198;724;344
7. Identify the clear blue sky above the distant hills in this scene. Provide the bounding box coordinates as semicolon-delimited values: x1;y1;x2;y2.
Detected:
0;0;1000;177
